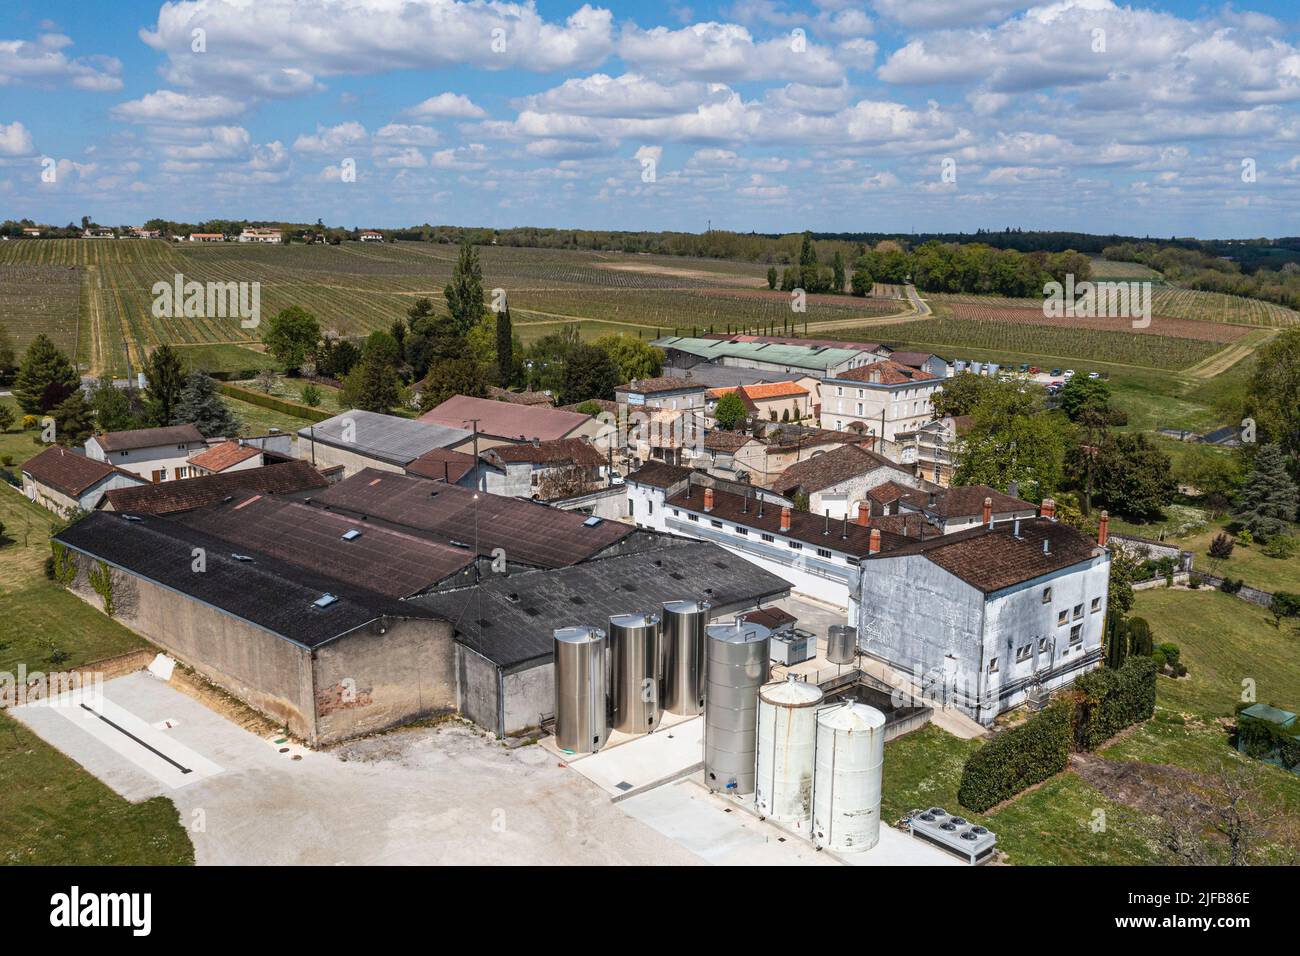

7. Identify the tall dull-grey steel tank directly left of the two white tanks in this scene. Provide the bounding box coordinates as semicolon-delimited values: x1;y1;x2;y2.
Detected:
705;622;772;793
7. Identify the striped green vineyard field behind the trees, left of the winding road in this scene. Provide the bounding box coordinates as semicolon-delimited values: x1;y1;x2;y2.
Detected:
0;239;901;373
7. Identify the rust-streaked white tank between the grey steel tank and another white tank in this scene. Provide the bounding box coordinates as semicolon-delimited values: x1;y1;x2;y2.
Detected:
754;676;823;832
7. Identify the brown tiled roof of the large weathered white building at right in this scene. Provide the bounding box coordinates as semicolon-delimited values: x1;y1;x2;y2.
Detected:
868;518;1104;593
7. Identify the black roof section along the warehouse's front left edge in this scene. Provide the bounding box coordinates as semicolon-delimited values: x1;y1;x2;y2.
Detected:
55;511;437;648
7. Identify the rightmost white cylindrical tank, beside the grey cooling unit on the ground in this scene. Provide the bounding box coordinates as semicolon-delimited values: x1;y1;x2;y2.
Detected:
813;702;885;853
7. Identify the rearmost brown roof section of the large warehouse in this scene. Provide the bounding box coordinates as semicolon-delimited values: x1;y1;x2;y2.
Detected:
304;468;633;567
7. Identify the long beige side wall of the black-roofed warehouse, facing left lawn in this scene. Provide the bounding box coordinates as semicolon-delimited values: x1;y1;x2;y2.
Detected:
72;553;315;740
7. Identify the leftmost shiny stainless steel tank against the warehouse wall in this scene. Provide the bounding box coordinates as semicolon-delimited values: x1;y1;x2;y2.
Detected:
555;627;610;753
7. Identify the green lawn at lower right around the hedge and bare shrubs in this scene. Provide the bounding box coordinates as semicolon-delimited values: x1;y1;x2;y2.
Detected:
880;589;1300;865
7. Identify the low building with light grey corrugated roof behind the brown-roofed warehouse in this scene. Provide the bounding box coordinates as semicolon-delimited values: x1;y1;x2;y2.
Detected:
298;408;473;475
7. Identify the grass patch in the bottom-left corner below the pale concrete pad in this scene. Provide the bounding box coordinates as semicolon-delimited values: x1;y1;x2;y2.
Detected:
0;714;194;866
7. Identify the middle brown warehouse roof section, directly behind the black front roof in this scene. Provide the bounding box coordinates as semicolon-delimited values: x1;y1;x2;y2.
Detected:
174;494;473;597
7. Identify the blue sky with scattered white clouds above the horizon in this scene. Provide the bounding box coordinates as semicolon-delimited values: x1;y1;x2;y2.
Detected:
0;0;1300;237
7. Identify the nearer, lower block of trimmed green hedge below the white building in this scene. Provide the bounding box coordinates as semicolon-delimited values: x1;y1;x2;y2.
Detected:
957;700;1073;813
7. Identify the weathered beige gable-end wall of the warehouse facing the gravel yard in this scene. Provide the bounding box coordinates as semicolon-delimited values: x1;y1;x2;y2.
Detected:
312;620;456;744
